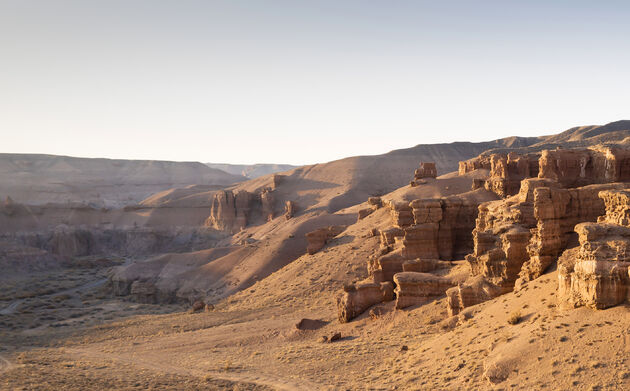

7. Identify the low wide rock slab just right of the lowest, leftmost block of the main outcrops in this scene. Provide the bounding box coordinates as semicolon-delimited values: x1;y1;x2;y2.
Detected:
394;272;454;308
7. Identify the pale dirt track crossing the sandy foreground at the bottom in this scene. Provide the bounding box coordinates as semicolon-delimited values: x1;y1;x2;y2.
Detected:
64;348;328;391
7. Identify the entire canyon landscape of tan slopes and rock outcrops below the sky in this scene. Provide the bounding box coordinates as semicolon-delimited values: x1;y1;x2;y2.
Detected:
0;121;630;390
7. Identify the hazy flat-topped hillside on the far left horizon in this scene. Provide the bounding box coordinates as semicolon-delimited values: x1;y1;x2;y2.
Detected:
0;153;246;207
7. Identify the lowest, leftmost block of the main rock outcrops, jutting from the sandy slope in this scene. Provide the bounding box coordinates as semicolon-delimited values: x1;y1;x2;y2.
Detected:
337;282;394;323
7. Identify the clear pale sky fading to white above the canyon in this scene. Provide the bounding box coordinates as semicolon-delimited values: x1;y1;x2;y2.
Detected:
0;0;630;165
